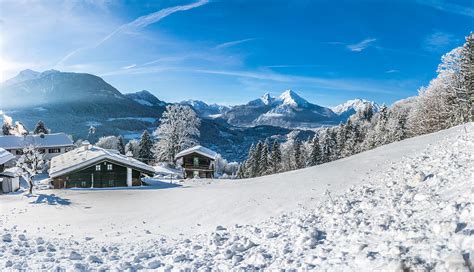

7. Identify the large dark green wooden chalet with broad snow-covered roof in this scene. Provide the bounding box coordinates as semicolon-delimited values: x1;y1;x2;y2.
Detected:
49;142;154;189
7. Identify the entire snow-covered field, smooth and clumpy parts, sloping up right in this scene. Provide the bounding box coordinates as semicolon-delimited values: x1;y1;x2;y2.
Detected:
0;123;474;271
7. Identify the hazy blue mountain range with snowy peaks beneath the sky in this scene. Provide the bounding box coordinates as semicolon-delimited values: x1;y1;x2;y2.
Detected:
0;70;378;161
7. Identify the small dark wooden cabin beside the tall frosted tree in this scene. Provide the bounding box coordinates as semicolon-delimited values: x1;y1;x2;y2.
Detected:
175;145;217;178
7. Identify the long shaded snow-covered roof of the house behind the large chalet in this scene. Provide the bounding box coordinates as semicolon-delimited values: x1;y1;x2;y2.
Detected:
0;133;74;149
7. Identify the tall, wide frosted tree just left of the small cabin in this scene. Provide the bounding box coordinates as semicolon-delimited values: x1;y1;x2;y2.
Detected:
155;105;201;163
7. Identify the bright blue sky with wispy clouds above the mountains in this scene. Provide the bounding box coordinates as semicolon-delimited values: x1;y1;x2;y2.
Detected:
0;0;474;106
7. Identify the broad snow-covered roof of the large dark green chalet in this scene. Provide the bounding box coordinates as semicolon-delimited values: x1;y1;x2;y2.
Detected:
49;145;155;178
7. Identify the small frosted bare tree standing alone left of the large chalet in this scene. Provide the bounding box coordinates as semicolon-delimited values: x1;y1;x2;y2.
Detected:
16;145;44;194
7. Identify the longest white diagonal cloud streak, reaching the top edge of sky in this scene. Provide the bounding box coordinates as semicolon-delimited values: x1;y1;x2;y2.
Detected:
56;0;209;66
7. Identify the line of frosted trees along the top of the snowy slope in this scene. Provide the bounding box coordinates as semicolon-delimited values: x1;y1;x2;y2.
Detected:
237;33;474;178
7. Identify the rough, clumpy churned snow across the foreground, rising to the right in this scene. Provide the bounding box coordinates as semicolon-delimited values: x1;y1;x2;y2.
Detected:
0;124;474;271
